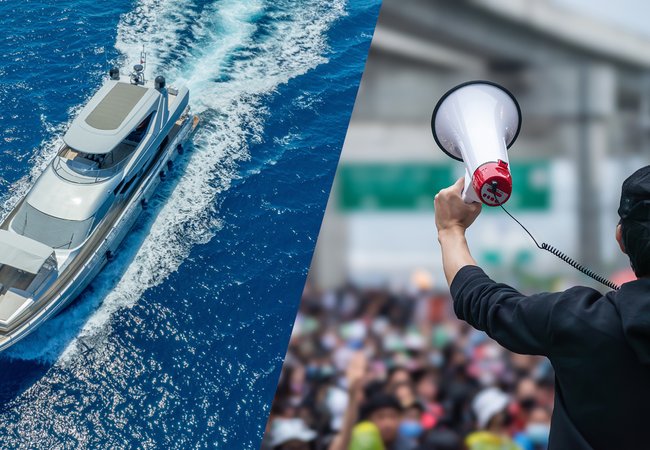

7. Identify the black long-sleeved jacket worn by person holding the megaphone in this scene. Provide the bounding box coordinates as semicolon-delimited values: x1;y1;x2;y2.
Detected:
451;266;650;450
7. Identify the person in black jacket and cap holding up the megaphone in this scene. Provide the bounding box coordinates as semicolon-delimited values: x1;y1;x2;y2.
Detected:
434;166;650;450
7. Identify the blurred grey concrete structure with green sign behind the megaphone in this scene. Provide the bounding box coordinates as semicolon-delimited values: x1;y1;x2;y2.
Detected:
311;0;650;288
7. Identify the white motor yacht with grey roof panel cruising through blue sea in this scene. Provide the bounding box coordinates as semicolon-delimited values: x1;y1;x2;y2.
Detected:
0;60;198;351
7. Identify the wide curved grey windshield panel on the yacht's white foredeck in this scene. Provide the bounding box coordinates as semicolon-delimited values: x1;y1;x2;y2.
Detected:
11;202;93;249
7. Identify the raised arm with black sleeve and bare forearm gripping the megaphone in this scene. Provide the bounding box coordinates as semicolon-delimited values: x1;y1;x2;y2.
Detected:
434;178;601;355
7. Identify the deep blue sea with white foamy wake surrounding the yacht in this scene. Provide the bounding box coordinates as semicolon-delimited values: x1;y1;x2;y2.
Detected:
0;0;380;449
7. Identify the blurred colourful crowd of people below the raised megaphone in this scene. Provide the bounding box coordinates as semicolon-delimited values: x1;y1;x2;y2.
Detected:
262;275;554;450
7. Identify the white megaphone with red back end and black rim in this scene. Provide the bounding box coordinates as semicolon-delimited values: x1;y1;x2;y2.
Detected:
431;81;521;206
